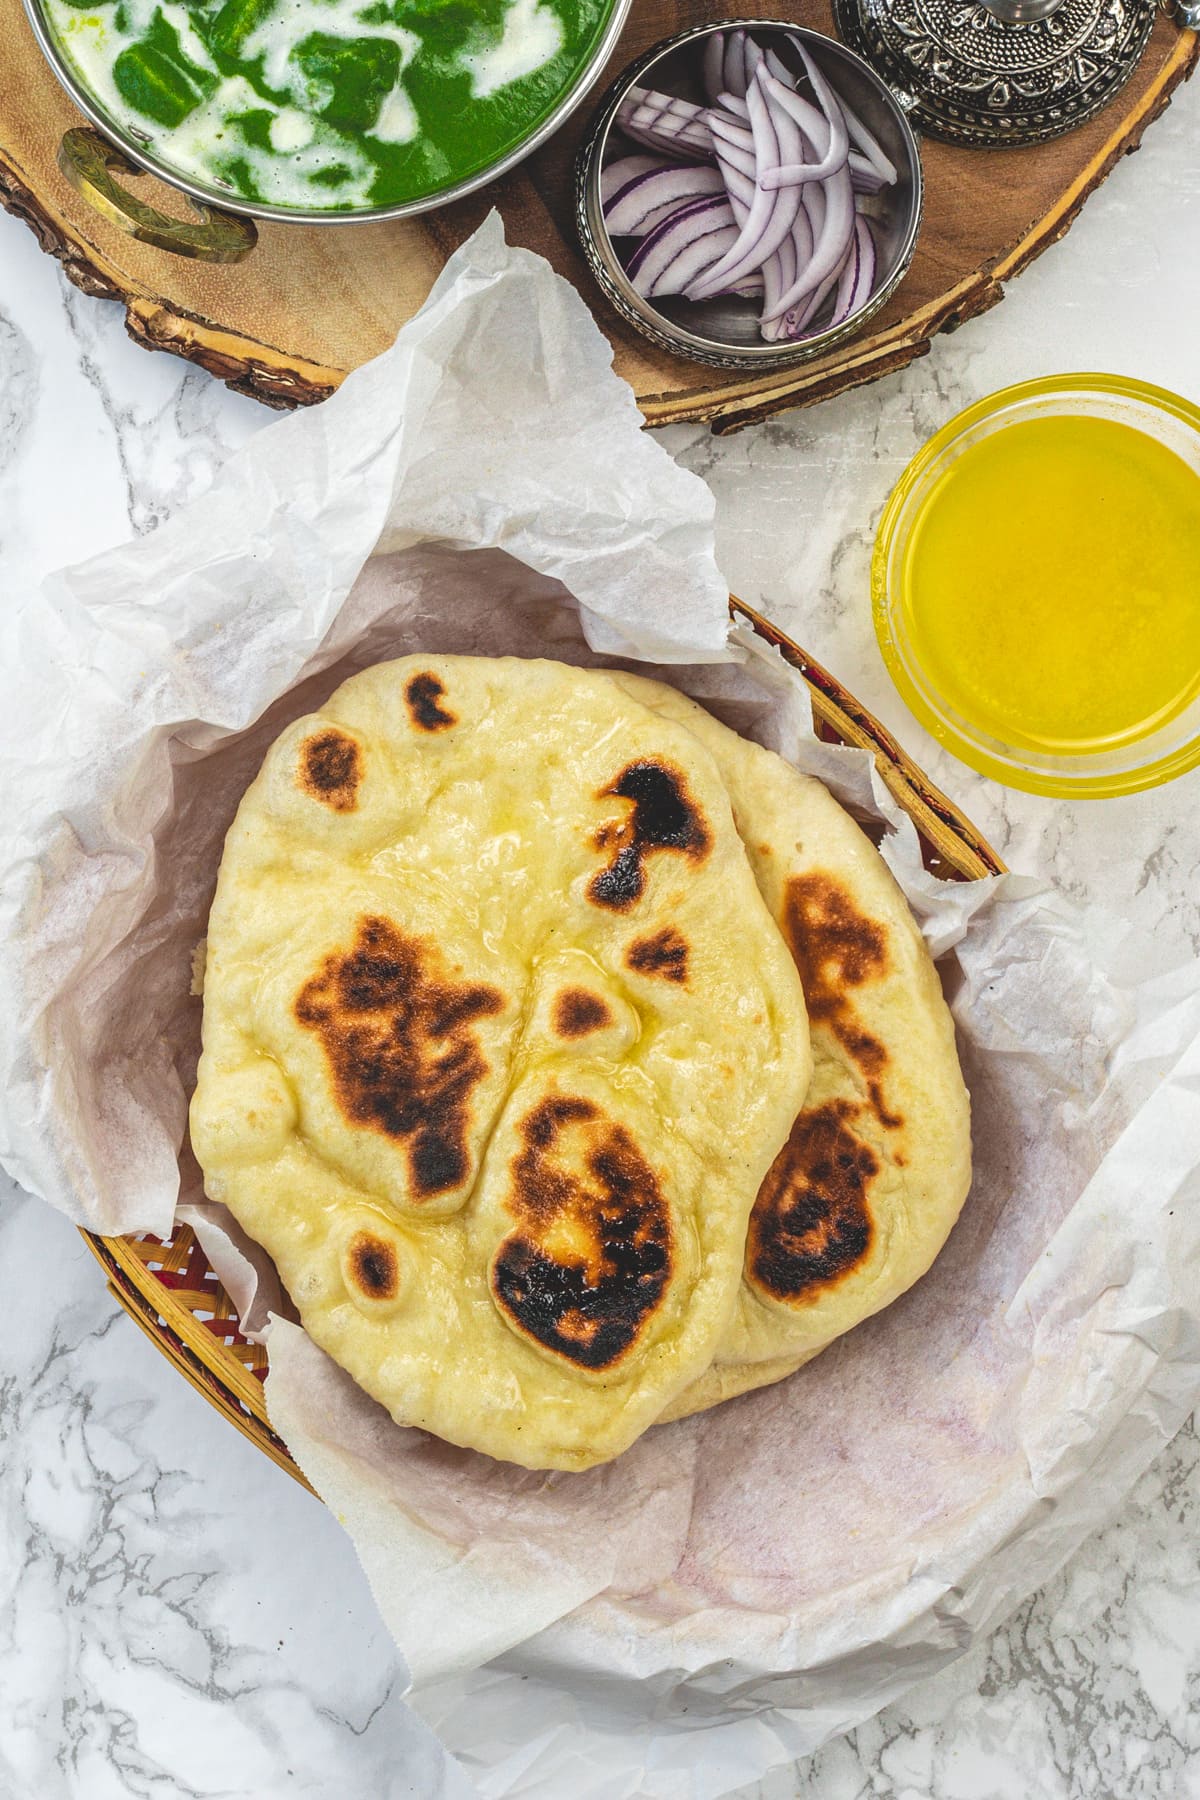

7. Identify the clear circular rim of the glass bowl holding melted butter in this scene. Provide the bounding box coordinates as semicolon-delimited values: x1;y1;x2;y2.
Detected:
871;371;1200;799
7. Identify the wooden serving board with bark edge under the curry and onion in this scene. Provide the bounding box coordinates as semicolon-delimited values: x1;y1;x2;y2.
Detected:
0;0;1200;432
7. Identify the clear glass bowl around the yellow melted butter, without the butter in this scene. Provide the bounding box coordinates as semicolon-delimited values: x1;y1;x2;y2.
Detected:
871;374;1200;799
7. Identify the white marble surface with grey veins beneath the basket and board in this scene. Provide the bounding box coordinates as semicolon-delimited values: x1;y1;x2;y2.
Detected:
0;85;1200;1800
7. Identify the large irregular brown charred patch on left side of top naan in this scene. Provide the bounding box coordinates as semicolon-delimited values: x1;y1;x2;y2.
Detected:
293;916;504;1201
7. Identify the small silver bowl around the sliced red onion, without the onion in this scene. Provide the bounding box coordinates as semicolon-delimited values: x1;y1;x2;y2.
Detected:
576;18;925;369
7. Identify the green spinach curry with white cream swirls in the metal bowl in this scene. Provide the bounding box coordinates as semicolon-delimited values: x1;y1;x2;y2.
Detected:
45;0;612;212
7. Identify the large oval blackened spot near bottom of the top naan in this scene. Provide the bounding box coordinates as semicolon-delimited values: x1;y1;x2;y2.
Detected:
491;1094;675;1370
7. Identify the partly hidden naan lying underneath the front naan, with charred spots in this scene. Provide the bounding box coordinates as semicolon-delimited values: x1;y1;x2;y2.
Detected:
617;675;972;1418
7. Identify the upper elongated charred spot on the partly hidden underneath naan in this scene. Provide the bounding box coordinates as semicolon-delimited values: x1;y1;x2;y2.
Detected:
783;869;903;1130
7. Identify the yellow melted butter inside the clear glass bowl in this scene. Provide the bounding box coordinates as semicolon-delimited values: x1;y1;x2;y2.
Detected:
901;416;1200;754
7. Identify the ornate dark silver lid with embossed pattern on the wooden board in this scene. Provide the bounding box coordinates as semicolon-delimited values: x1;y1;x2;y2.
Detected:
833;0;1155;149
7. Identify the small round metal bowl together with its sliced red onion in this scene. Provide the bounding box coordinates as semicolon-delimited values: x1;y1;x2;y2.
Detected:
576;20;923;369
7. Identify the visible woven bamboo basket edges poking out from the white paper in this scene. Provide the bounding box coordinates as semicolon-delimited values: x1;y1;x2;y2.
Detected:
83;599;1004;1487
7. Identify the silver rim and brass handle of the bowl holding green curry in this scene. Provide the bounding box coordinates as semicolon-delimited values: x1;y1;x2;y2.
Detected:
25;0;633;263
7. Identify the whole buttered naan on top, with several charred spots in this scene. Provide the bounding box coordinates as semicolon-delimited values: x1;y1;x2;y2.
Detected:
191;657;811;1469
